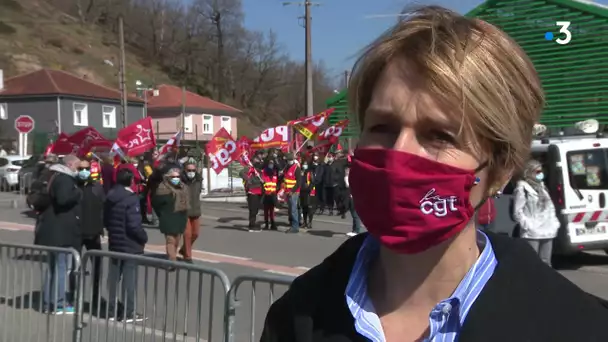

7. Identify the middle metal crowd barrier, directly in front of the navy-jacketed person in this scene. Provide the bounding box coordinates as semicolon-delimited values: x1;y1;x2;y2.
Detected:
73;251;230;342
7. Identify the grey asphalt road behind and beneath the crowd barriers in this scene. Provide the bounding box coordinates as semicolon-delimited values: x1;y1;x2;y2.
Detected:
0;194;608;342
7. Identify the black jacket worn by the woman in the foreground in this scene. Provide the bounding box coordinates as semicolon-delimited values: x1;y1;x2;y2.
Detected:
261;233;608;342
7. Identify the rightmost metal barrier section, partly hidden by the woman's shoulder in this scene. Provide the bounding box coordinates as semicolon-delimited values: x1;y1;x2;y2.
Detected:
225;275;294;342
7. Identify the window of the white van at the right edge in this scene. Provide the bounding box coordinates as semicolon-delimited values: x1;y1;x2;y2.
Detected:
566;148;608;190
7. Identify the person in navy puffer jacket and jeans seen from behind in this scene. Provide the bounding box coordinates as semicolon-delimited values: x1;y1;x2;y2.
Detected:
103;169;148;322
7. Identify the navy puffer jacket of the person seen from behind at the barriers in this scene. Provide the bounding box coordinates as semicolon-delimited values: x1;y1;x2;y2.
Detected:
103;184;148;254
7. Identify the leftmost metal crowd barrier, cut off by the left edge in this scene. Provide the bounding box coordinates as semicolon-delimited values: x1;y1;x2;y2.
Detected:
0;243;80;342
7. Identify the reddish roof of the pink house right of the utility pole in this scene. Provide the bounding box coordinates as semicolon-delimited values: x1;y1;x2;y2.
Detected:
148;84;242;115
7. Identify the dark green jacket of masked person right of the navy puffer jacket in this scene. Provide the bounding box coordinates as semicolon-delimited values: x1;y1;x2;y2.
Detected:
152;182;190;235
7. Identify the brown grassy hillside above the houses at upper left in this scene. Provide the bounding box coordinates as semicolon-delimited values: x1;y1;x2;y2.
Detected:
0;0;266;135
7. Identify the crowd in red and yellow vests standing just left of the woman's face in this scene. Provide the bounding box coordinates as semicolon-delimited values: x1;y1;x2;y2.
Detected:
241;147;361;236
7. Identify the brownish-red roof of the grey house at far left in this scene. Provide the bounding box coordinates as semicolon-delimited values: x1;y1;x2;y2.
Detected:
0;69;143;103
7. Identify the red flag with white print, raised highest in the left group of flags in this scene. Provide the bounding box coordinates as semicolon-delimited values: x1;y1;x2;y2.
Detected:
116;117;156;157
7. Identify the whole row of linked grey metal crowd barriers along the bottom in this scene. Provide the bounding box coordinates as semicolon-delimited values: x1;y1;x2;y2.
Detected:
0;243;300;342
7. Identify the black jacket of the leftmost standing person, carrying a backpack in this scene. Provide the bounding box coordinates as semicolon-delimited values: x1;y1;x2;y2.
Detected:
34;164;82;250
